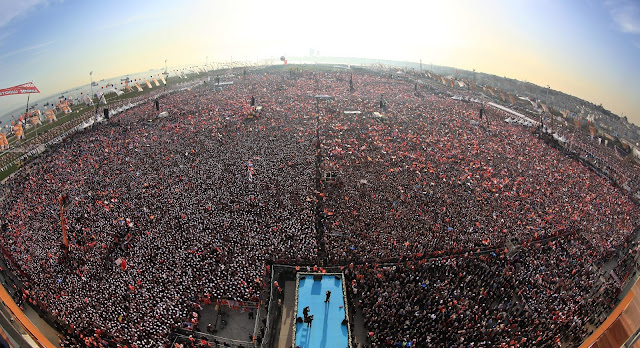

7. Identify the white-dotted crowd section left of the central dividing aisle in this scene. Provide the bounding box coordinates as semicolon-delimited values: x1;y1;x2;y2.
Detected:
3;72;316;347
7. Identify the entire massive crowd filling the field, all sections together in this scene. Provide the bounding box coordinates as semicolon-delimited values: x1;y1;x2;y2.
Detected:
0;72;640;347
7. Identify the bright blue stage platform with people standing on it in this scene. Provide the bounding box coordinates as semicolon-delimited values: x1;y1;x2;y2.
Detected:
294;273;350;348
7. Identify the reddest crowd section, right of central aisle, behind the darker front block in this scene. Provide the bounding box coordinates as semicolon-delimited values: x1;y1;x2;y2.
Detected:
321;75;638;261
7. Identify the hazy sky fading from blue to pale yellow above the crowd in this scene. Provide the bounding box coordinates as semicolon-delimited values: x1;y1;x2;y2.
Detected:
0;0;640;125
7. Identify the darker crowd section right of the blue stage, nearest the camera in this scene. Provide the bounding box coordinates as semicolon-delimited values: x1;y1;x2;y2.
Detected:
346;237;616;347
